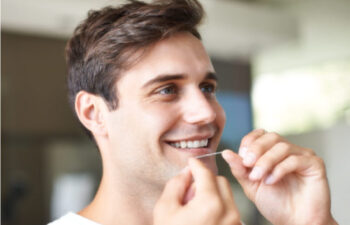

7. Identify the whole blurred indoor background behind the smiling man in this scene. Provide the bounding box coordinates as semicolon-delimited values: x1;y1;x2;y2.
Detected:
1;0;350;225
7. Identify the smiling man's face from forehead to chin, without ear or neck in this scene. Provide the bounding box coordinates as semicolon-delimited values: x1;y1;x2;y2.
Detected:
102;33;225;184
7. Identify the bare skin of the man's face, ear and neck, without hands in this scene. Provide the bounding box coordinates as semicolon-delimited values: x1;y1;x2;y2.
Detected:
75;33;225;224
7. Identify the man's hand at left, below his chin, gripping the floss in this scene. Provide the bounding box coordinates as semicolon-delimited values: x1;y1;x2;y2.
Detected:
153;158;241;225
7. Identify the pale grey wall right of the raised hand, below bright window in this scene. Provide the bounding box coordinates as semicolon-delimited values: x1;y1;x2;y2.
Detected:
286;123;350;224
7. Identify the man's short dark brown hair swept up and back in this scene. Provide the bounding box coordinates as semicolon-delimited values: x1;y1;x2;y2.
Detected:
66;0;204;137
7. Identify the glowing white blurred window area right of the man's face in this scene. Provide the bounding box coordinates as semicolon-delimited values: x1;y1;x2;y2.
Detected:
252;60;350;134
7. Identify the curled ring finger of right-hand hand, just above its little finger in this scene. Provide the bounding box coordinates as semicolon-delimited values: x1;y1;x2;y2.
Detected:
249;142;297;181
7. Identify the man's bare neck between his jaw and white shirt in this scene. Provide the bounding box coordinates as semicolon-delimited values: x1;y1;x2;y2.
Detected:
79;167;162;225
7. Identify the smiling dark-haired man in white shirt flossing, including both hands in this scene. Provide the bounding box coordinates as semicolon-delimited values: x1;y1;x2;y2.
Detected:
49;0;336;225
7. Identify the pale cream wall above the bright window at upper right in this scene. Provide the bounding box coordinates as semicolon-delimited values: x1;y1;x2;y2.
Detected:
253;0;350;74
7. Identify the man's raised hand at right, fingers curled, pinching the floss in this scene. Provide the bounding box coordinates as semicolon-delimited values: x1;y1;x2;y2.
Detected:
222;129;336;225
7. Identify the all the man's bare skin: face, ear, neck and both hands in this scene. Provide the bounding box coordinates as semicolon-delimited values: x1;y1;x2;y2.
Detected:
76;33;335;225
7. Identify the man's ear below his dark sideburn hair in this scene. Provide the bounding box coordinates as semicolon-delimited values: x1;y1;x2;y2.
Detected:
75;91;107;136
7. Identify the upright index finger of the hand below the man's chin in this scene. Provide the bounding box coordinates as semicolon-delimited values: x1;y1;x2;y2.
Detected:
188;158;218;195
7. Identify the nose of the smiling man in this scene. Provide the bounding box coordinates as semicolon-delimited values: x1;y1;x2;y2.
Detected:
183;90;216;125
